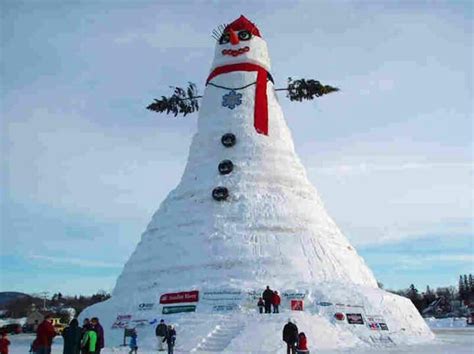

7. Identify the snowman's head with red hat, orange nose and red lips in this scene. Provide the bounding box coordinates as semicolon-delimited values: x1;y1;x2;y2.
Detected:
211;15;270;71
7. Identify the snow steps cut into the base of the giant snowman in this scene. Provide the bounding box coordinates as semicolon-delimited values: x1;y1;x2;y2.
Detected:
191;318;245;353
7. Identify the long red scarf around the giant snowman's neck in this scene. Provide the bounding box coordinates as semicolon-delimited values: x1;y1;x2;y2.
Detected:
206;63;268;135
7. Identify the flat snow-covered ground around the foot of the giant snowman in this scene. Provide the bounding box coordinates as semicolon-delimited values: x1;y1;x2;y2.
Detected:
10;327;474;354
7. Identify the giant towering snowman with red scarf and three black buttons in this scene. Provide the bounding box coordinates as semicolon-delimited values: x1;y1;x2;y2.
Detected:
82;16;432;352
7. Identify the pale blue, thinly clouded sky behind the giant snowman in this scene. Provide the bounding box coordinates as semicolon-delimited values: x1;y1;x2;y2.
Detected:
0;0;474;294
